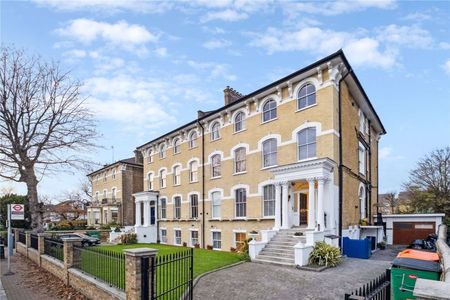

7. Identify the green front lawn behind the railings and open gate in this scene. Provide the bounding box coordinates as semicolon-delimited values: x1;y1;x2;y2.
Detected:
77;244;244;299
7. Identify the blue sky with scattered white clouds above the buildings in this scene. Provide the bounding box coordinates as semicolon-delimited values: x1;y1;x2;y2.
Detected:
0;0;450;198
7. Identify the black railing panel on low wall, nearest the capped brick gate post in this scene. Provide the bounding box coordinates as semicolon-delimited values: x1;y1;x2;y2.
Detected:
73;246;125;290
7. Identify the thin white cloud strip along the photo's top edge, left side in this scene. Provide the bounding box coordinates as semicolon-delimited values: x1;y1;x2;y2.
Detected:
33;0;173;14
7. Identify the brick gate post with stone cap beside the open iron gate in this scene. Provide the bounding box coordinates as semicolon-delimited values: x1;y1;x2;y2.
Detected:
124;248;158;300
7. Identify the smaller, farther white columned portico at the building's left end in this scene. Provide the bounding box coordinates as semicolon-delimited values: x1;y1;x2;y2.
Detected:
133;191;158;243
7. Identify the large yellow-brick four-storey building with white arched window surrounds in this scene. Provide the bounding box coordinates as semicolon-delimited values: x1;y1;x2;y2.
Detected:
89;51;386;251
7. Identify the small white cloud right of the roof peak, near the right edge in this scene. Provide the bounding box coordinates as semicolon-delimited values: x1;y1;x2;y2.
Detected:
377;24;433;48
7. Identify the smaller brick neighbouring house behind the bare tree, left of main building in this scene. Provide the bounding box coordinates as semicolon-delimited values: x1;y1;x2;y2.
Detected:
87;153;143;226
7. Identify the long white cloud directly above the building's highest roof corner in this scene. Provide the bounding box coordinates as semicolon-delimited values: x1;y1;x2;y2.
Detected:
246;27;397;68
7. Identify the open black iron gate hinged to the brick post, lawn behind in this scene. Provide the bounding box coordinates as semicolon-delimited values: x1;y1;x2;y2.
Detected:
141;249;194;300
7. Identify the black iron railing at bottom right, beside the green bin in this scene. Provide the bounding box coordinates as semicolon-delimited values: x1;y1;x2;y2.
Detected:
345;269;391;300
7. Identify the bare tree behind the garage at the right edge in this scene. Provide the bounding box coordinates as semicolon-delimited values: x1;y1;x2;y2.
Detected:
405;147;450;216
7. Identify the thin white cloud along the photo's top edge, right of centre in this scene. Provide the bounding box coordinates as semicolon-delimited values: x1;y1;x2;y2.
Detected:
283;0;395;18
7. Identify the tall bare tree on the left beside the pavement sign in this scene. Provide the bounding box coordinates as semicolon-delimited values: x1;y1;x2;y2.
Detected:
0;48;97;231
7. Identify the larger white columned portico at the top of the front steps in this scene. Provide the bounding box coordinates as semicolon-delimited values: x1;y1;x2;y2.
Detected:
271;158;338;233
